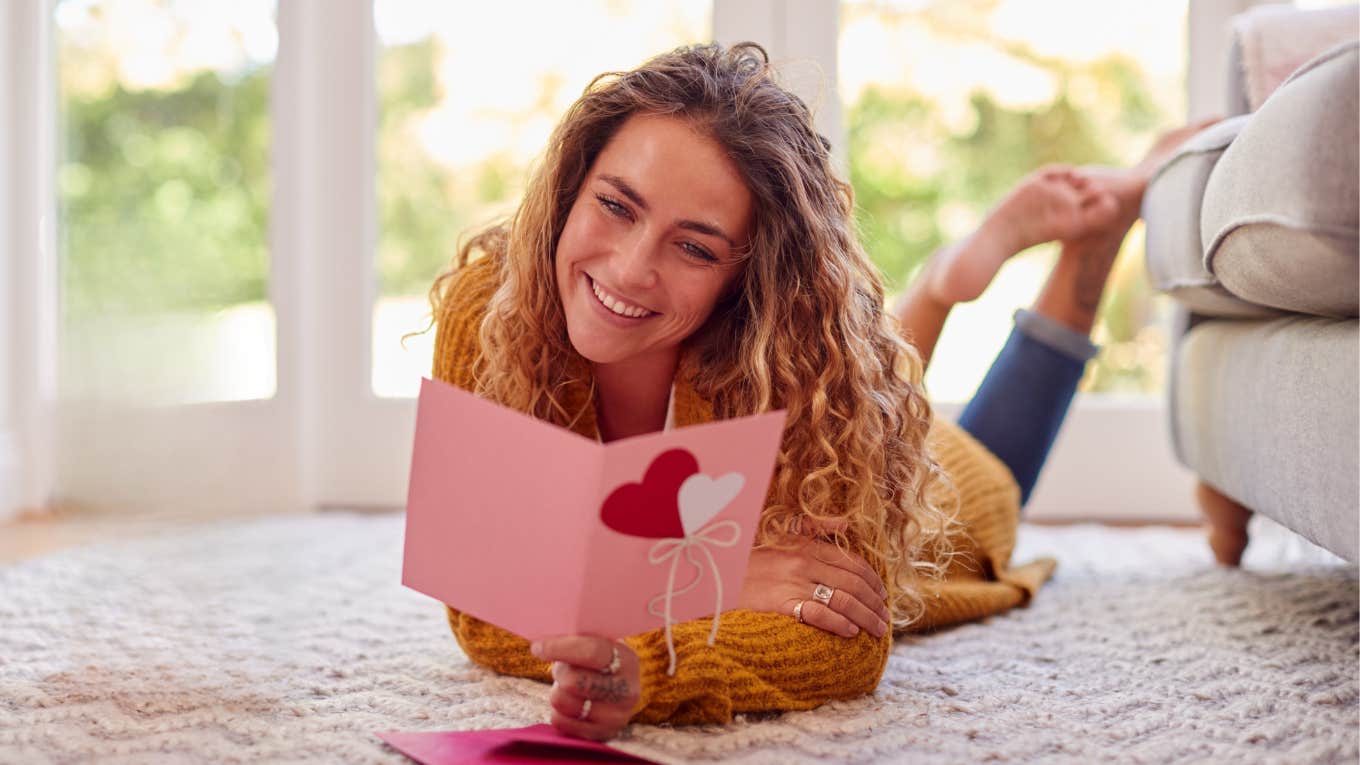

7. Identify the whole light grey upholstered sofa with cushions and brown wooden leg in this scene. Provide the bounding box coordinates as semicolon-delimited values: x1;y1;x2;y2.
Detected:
1142;10;1360;565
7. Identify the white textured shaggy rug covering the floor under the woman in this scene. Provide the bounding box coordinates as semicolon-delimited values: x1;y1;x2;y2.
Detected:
0;515;1360;765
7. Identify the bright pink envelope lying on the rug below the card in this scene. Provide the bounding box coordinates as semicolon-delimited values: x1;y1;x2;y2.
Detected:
374;726;651;765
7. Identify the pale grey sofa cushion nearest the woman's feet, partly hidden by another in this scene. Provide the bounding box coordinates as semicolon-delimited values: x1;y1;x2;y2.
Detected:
1142;114;1278;317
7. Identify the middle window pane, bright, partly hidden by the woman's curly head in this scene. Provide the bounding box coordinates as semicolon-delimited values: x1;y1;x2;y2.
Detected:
371;0;711;396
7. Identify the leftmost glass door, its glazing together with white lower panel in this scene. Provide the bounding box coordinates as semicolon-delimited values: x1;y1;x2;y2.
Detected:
46;0;296;512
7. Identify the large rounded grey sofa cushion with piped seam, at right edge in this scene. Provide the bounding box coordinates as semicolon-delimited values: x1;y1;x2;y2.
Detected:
1200;42;1360;317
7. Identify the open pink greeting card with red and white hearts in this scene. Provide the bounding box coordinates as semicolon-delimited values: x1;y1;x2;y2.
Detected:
401;378;785;640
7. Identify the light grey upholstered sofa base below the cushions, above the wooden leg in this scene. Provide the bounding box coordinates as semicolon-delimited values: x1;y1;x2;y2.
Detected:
1171;316;1360;562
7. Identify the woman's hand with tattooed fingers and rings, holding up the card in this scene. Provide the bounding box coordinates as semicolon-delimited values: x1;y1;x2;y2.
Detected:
529;634;642;740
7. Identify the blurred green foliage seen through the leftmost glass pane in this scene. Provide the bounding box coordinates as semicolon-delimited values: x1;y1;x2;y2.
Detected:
57;67;269;316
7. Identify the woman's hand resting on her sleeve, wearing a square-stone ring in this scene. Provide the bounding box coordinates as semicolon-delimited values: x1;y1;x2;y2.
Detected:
737;522;891;637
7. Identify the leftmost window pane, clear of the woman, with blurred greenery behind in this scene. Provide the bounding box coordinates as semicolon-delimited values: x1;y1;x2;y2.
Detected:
56;0;277;404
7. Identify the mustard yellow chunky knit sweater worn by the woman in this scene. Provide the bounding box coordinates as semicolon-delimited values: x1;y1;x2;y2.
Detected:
434;259;1054;724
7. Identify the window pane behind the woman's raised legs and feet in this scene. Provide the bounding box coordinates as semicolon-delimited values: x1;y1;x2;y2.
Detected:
839;0;1186;400
